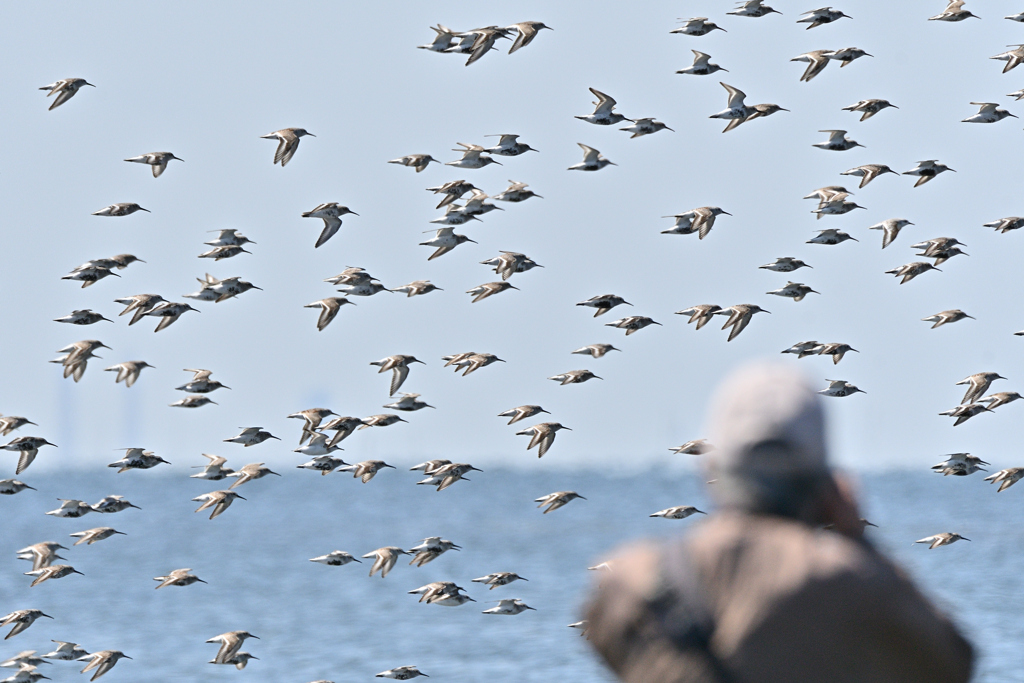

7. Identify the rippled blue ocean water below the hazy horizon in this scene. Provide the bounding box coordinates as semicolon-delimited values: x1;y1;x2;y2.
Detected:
0;466;1024;683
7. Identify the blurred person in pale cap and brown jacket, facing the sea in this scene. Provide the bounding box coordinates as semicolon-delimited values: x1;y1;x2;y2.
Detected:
587;365;973;683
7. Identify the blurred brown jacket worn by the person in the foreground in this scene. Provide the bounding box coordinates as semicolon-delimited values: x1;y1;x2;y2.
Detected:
588;513;973;683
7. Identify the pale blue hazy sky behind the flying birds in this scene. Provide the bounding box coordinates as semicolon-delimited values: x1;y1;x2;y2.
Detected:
0;0;1024;478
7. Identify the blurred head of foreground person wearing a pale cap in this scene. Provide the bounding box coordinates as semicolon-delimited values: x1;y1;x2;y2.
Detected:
709;362;836;523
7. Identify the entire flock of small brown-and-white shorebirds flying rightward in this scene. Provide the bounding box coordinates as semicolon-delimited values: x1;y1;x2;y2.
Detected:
0;0;1024;683
